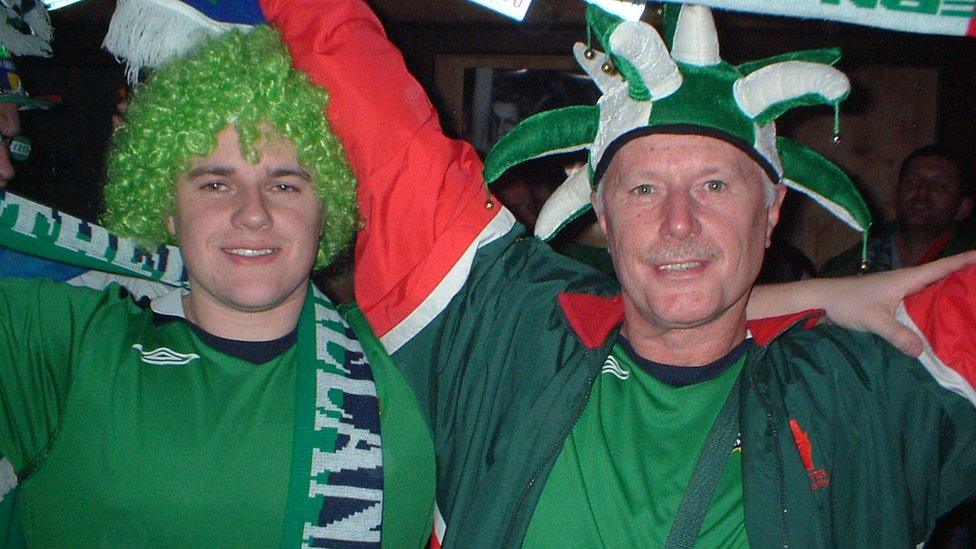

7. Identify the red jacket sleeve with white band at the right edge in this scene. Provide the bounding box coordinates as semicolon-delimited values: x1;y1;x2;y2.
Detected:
897;266;976;404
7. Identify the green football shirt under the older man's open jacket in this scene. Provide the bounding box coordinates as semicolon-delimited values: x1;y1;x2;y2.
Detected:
523;342;749;548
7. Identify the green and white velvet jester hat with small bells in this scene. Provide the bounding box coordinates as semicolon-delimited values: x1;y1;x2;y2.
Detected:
485;4;871;266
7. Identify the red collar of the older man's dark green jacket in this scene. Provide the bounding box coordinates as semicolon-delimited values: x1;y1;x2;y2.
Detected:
559;293;824;349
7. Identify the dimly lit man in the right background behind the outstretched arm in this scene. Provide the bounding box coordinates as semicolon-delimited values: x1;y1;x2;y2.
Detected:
820;145;976;277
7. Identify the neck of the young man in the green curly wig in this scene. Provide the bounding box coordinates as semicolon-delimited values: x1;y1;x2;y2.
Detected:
183;286;307;341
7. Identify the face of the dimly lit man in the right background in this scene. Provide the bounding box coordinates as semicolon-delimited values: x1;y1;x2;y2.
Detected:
896;156;969;234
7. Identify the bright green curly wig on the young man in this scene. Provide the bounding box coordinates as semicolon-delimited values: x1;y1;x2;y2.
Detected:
102;26;356;268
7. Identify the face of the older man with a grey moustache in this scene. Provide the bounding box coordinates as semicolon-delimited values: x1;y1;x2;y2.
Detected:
598;135;785;332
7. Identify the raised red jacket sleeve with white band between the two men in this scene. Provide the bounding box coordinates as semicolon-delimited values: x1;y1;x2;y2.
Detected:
261;0;514;338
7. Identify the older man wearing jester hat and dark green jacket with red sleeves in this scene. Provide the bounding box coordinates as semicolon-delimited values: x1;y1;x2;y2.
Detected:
248;0;976;547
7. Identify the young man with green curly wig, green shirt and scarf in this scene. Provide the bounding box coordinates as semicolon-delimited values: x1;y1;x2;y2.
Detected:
0;27;433;547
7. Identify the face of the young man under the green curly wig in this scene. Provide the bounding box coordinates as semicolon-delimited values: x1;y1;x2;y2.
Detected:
168;127;322;312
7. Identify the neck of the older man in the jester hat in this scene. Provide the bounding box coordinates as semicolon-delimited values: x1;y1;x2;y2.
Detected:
621;307;746;366
